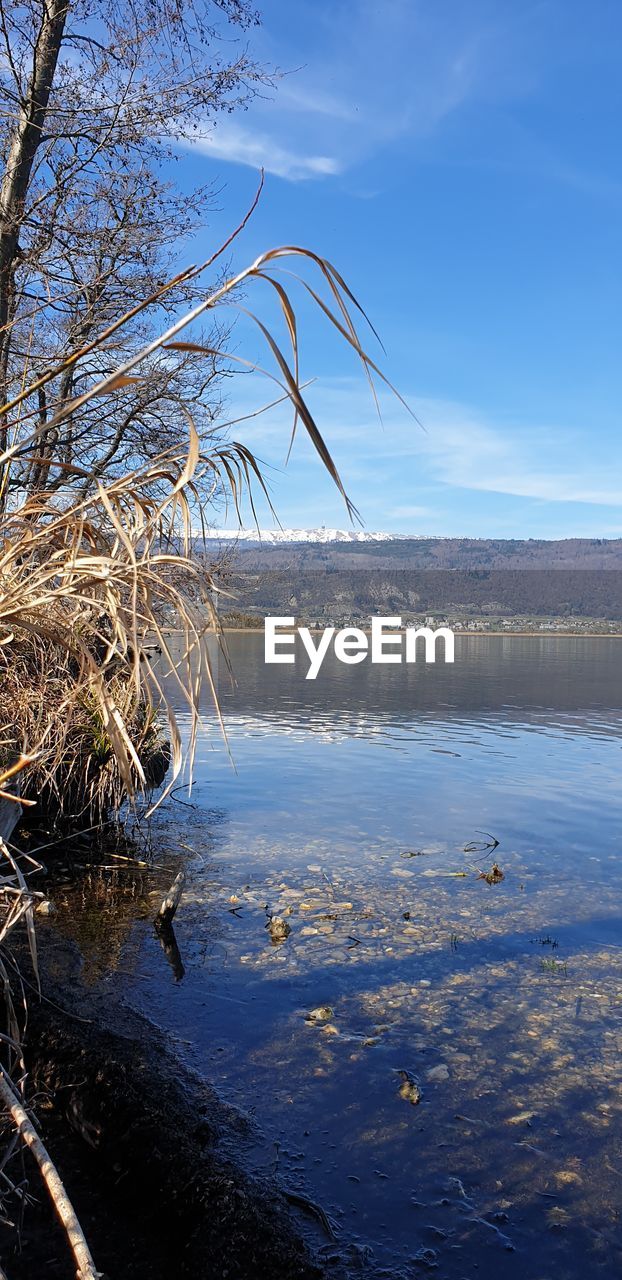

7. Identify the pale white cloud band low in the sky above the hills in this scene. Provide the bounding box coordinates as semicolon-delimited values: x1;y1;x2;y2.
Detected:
221;378;622;506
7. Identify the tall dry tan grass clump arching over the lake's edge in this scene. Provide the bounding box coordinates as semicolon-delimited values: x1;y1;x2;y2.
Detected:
0;236;406;805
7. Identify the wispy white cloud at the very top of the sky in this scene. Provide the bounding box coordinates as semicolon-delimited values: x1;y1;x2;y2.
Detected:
180;0;524;182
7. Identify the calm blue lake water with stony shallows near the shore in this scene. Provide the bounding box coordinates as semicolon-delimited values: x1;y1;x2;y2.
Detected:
58;634;622;1280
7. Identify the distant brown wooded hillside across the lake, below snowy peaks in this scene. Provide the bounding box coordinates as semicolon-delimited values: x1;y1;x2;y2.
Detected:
207;538;622;630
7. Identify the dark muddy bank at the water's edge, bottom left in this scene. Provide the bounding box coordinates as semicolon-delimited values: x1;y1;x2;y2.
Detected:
0;927;324;1280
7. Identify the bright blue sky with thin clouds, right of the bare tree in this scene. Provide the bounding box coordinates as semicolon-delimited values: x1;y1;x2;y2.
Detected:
177;0;622;538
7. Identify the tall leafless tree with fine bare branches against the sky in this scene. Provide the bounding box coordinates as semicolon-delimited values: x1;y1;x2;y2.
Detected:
0;0;266;492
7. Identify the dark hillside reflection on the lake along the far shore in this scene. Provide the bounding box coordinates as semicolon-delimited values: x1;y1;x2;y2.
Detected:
206;632;622;735
